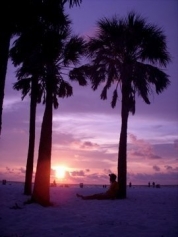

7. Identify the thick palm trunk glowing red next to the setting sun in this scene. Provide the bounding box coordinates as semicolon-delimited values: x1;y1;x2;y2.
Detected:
32;83;52;206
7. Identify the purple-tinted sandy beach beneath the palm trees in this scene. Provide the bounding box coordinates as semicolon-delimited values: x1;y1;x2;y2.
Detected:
0;183;178;237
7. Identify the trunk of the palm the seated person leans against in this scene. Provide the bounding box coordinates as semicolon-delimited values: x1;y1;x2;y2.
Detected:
118;86;129;199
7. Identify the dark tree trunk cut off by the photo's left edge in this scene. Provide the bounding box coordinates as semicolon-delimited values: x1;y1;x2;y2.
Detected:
0;31;11;134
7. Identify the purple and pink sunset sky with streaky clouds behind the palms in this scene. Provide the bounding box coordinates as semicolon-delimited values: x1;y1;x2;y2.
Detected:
0;0;178;184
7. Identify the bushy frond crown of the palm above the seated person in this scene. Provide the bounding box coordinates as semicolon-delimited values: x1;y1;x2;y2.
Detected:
88;12;170;110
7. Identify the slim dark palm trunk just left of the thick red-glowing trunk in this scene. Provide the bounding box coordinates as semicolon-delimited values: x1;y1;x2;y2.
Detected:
24;78;38;195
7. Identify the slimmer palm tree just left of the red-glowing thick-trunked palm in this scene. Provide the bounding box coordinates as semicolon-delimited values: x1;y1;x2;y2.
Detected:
10;9;49;195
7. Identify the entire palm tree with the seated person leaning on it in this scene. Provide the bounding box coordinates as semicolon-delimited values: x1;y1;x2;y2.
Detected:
72;12;170;198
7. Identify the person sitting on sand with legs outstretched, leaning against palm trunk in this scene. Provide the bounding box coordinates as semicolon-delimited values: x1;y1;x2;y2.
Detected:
76;174;119;200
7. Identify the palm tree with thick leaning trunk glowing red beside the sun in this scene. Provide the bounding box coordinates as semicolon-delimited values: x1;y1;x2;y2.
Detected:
32;21;86;206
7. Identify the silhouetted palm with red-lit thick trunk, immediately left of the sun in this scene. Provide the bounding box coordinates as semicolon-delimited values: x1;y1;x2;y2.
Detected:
32;33;86;206
